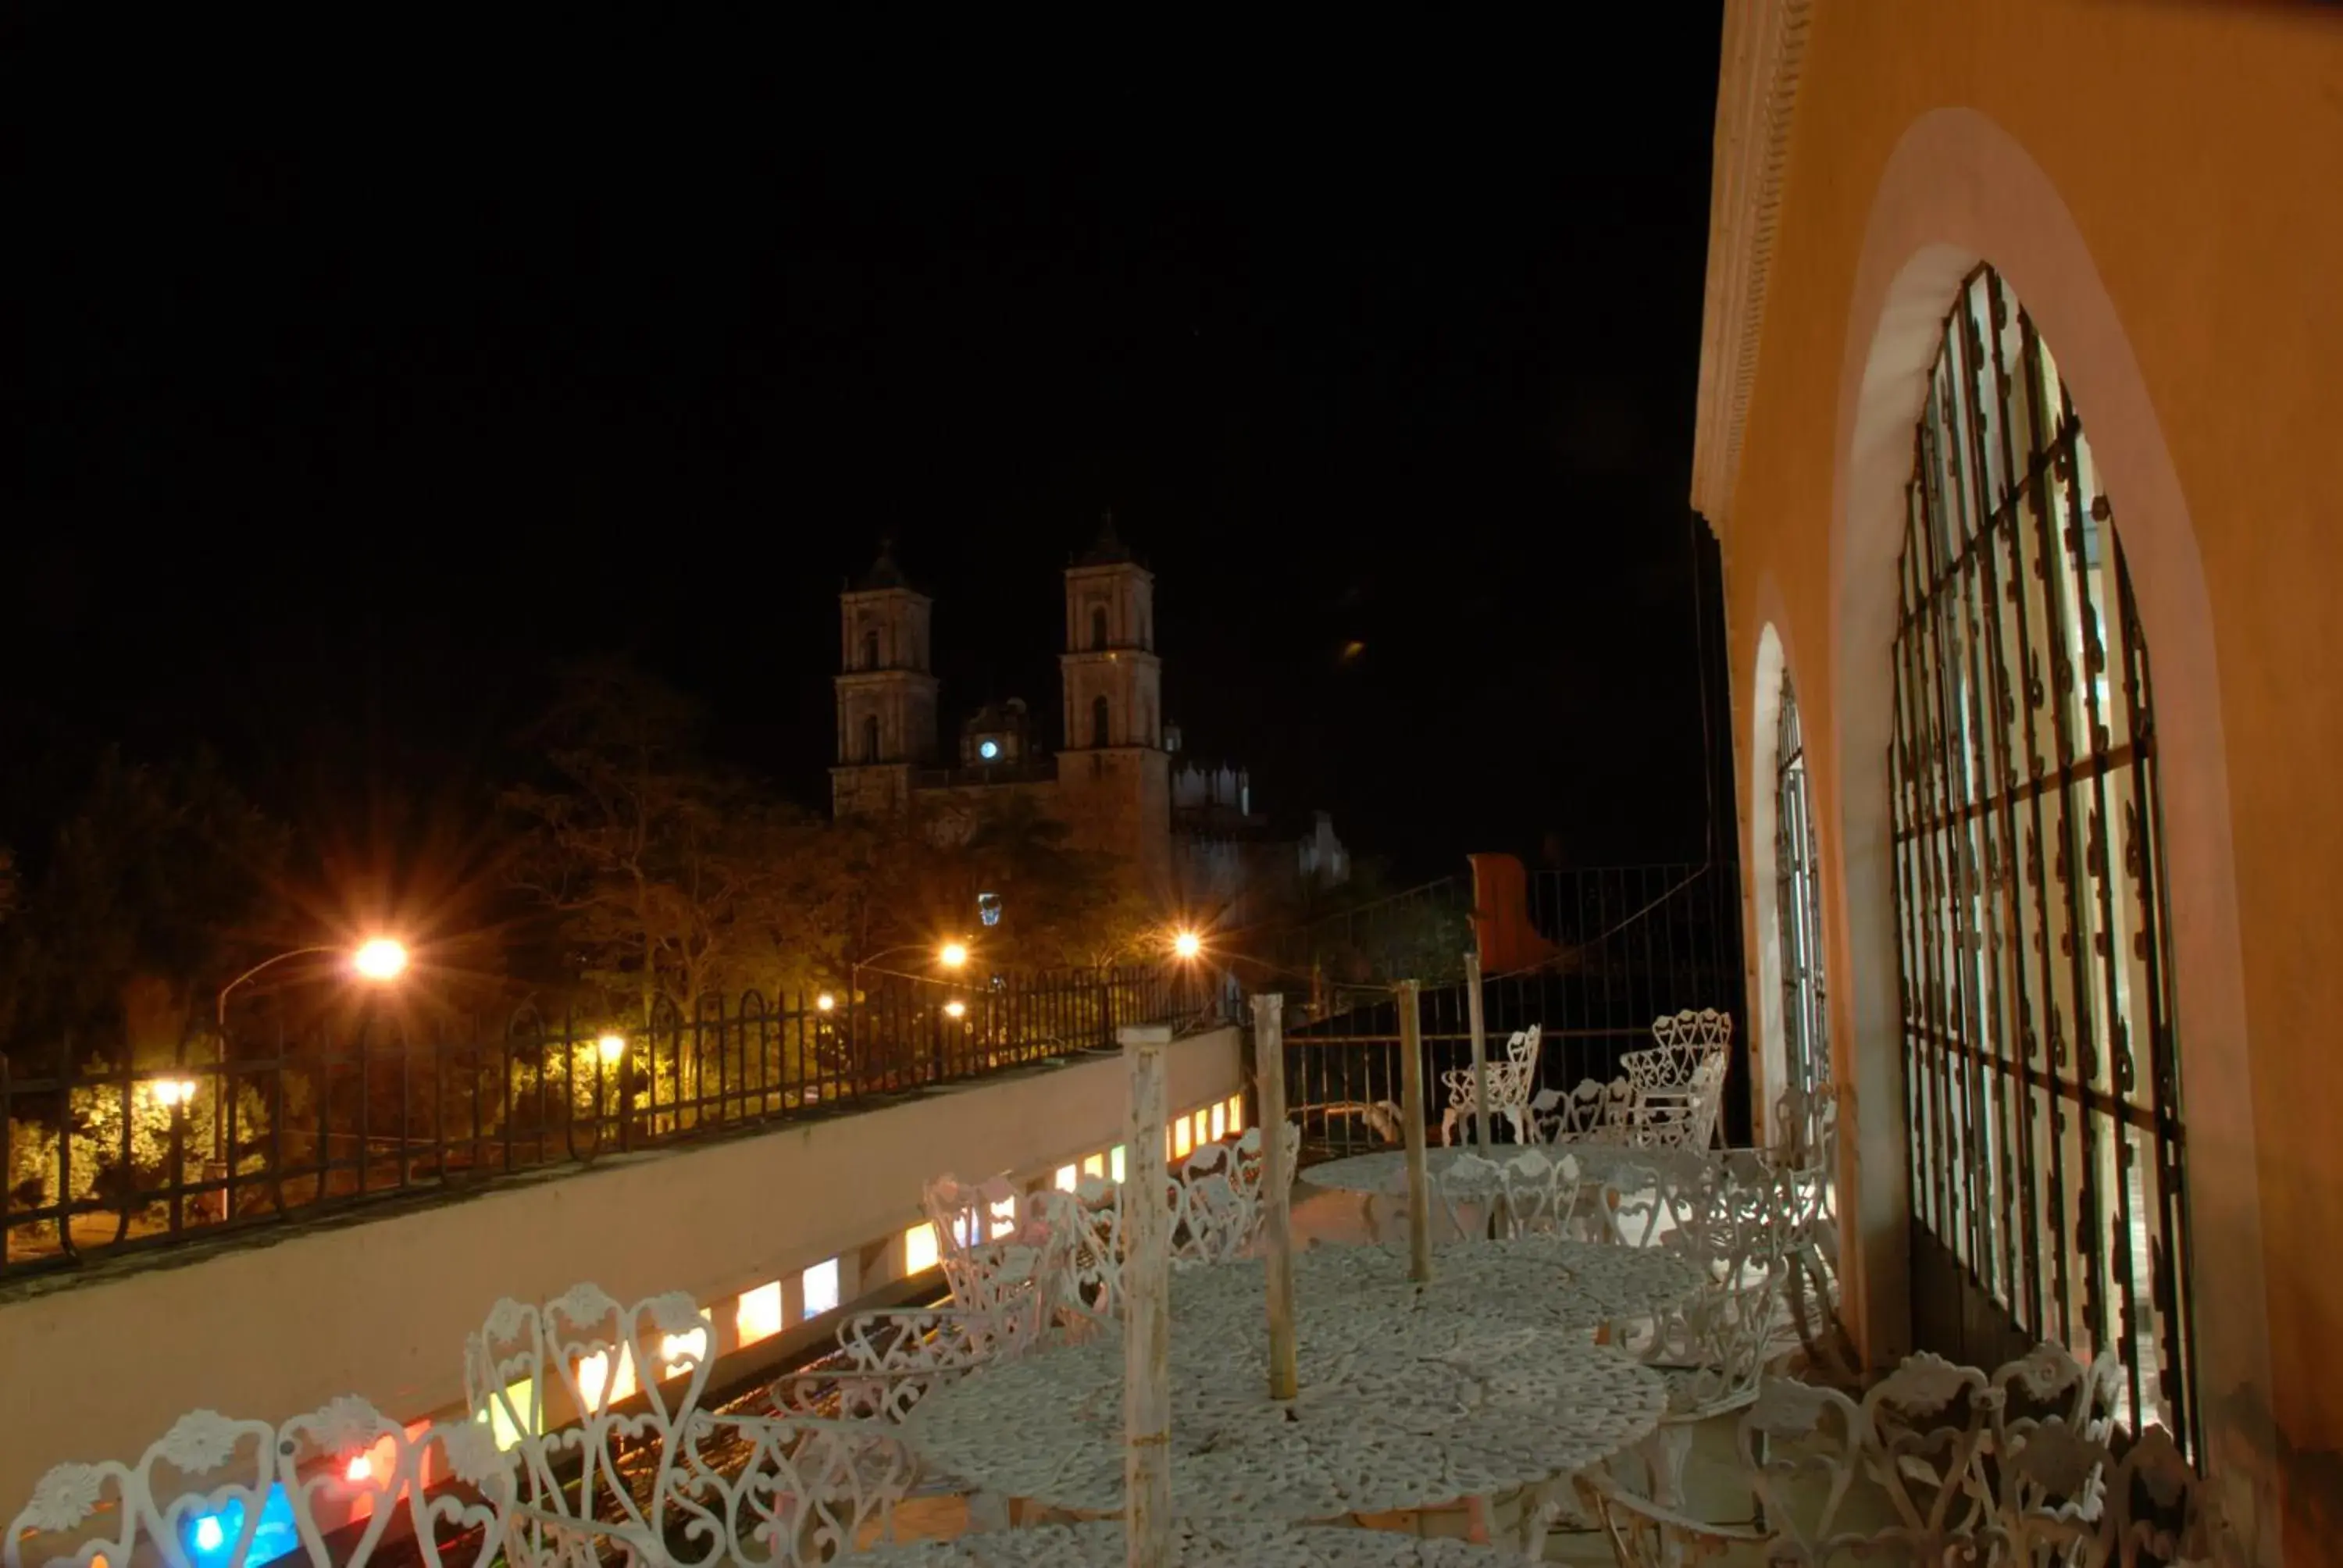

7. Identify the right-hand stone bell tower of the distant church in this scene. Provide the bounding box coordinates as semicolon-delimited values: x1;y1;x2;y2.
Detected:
1057;513;1172;891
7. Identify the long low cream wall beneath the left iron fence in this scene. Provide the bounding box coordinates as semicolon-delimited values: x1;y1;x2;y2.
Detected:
0;1029;1242;1519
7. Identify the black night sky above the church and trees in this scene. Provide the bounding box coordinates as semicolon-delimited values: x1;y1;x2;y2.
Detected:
0;18;1715;875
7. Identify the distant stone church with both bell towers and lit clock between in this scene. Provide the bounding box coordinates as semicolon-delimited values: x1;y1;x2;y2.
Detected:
829;518;1350;924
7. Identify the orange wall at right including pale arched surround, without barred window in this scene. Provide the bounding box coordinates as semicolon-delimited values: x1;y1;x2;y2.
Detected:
1710;0;2343;1561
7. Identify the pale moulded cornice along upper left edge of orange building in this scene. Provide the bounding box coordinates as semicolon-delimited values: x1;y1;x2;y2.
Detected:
1692;0;1809;539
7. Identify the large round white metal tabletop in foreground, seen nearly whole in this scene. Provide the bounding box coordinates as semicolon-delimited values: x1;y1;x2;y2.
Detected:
904;1296;1668;1521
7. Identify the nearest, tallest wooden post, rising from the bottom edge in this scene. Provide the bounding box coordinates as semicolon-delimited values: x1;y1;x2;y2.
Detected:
1118;1025;1172;1568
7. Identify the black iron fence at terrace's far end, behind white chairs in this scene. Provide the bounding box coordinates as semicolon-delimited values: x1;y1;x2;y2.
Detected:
1286;863;1750;1158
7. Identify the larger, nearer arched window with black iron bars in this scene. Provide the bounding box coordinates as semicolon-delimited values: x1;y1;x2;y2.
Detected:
1891;267;2200;1453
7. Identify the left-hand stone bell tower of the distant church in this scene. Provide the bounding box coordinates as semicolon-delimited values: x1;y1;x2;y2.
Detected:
829;541;937;818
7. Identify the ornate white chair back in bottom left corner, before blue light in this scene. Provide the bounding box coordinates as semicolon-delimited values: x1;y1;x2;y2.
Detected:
0;1395;515;1568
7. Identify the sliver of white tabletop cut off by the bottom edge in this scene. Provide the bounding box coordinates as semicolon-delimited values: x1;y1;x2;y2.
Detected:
853;1519;1521;1568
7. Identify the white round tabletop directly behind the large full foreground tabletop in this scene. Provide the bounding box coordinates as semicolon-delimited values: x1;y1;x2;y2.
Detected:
1172;1235;1703;1343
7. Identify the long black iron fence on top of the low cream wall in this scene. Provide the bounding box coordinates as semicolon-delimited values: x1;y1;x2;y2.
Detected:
0;968;1214;1278
